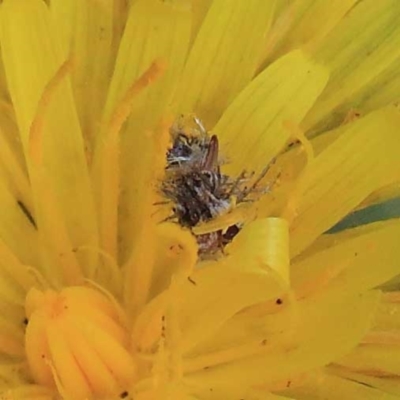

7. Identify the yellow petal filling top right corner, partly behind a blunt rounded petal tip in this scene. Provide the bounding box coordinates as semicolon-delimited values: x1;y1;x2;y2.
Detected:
304;0;400;134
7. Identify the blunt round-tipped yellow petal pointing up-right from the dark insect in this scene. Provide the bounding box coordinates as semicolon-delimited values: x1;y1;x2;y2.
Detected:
213;51;328;176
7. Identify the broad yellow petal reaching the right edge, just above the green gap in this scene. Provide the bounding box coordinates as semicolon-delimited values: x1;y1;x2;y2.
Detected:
290;107;400;256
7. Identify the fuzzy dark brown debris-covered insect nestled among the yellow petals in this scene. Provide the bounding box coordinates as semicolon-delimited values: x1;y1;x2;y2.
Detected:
161;118;276;258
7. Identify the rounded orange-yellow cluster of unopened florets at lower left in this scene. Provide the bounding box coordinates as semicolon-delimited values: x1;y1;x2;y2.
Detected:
25;286;136;400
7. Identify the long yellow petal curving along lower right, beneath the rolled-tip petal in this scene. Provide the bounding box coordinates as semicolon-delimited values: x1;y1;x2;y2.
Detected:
186;292;379;398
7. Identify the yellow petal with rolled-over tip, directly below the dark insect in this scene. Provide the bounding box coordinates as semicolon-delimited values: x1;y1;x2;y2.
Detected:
178;219;288;351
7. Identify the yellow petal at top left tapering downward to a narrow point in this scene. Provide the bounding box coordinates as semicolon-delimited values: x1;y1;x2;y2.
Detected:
50;0;114;149
